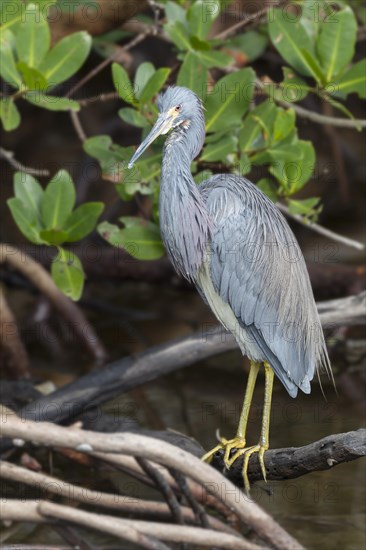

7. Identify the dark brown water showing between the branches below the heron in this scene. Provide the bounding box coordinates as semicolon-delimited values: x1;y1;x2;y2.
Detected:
2;284;366;550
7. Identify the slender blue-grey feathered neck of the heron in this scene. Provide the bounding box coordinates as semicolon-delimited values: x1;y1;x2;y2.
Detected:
160;128;210;281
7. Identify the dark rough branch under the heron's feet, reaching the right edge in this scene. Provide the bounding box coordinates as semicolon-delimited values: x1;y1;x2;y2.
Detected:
212;429;366;487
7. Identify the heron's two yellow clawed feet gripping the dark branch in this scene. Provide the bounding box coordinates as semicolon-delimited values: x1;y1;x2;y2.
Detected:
202;437;268;495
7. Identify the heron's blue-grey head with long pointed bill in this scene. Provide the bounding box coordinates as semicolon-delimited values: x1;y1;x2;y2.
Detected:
128;86;205;168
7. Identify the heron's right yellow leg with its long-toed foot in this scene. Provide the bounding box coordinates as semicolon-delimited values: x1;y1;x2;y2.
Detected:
229;362;274;493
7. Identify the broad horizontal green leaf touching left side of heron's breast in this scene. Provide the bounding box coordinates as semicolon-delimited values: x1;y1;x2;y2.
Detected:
98;222;165;260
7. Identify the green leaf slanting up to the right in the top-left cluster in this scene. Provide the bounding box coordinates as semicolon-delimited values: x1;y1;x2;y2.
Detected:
39;31;92;86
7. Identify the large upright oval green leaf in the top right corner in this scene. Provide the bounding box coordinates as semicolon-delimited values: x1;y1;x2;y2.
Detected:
316;6;357;82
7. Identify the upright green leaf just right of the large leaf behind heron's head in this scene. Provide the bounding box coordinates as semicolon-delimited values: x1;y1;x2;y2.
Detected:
239;100;277;152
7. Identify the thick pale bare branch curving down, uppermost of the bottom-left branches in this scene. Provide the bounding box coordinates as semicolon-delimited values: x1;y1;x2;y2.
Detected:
1;414;302;550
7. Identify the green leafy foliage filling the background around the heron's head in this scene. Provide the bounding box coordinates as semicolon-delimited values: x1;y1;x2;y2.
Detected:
0;0;366;300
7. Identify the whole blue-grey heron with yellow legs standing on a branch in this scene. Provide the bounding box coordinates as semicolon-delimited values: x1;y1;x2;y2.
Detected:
129;86;331;492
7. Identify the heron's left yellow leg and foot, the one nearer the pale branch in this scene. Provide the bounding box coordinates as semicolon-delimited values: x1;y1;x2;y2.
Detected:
202;361;260;468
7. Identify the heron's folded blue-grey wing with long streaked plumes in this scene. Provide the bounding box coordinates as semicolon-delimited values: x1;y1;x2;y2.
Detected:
200;174;329;397
